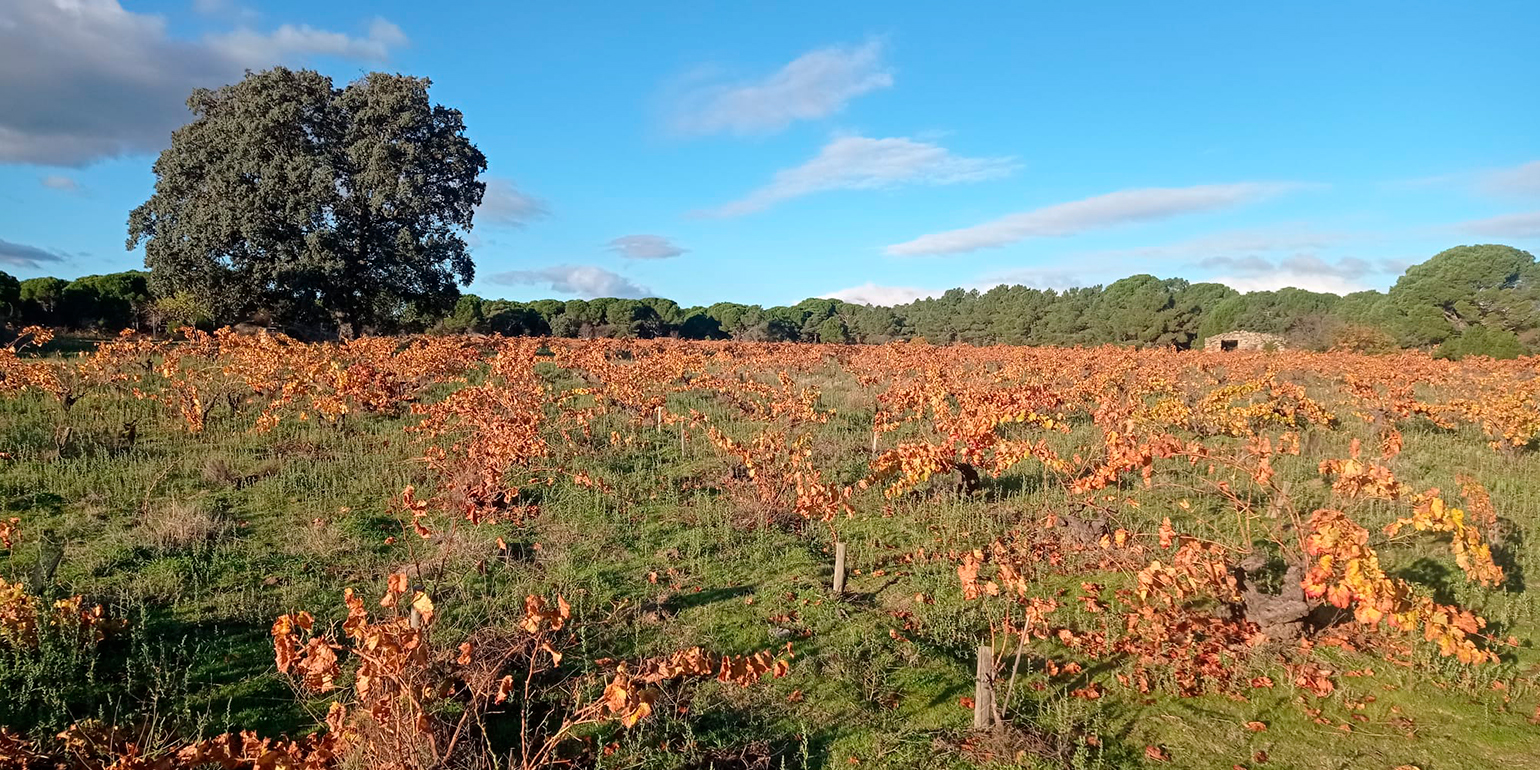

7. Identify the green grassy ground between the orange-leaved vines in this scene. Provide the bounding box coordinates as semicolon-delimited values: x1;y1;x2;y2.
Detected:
0;346;1540;770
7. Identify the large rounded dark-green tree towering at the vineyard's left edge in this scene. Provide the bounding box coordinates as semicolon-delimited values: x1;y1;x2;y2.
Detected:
128;68;487;334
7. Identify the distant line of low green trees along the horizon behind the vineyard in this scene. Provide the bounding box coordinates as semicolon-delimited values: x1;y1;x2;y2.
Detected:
9;245;1540;357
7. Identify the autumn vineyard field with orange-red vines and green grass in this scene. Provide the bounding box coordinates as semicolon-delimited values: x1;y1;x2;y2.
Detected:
0;328;1540;770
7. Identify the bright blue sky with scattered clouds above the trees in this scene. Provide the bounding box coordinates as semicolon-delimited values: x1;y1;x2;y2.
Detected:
0;0;1540;305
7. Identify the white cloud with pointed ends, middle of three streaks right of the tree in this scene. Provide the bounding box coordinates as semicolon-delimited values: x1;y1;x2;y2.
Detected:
702;137;1016;217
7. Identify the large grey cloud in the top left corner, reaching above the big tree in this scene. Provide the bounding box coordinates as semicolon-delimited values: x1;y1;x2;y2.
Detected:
0;0;405;166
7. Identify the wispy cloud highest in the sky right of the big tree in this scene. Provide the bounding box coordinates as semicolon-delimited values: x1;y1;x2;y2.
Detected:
670;40;893;136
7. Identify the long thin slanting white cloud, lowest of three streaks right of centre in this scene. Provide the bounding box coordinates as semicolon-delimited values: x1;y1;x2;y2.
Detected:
887;182;1298;256
